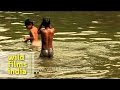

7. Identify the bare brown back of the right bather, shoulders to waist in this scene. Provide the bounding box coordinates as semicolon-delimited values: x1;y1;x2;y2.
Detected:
41;28;55;50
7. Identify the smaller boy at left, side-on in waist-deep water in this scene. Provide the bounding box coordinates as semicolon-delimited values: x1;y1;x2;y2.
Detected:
24;19;40;46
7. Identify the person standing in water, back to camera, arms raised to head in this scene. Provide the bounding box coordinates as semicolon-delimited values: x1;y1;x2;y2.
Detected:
38;18;55;57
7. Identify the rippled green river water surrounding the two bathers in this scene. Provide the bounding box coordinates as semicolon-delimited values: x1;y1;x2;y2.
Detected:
0;11;120;79
